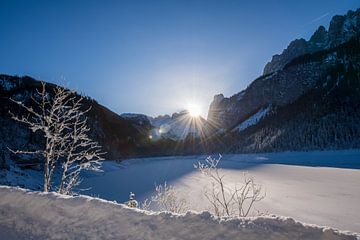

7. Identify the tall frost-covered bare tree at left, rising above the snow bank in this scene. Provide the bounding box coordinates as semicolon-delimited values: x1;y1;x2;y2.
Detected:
10;83;103;194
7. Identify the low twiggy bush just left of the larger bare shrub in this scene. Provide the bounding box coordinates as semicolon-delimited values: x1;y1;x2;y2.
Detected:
151;182;189;213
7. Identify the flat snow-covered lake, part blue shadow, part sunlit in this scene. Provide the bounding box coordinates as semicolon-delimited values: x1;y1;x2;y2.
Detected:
81;150;360;232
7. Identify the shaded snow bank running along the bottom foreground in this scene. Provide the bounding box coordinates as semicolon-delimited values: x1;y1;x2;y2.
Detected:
0;186;360;240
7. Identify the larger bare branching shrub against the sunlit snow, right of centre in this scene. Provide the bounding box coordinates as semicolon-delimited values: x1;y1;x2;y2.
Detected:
194;155;265;217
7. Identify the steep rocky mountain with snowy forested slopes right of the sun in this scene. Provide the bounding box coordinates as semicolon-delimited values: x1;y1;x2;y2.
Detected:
207;9;360;152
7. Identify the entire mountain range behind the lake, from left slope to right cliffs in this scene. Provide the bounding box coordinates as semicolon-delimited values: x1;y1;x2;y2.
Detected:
0;9;360;165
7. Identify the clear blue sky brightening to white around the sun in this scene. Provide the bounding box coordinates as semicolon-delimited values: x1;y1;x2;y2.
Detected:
0;0;360;115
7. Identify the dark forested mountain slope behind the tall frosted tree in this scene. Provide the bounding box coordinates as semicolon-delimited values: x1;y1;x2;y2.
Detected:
0;75;167;168
